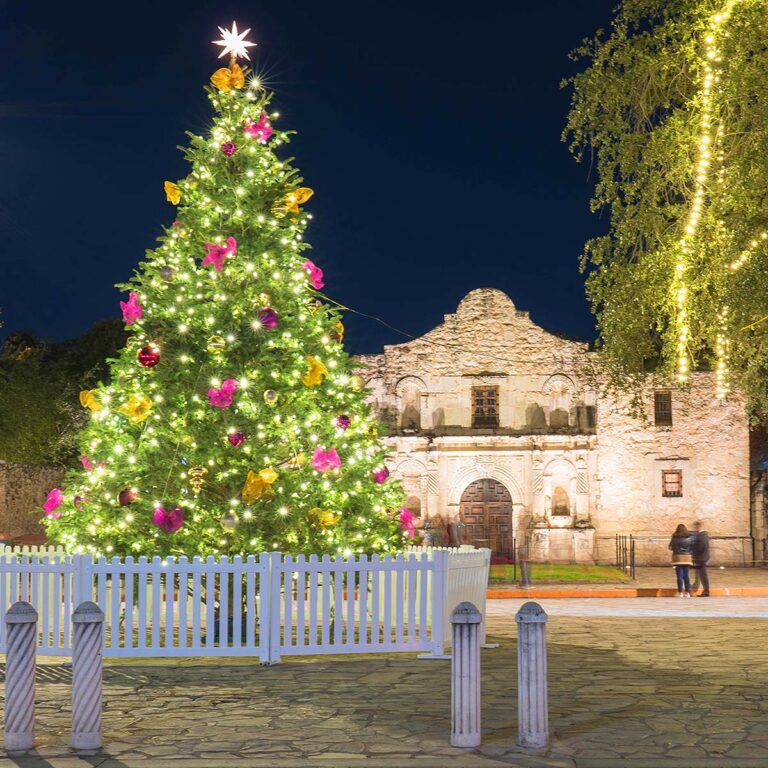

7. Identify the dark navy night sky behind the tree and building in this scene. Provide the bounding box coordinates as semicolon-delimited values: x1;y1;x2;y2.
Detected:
0;0;615;352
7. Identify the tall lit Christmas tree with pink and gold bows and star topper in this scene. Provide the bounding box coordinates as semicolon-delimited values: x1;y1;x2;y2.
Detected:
44;24;413;555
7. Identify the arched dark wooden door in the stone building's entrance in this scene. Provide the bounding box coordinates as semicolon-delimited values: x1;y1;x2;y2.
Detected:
460;478;512;556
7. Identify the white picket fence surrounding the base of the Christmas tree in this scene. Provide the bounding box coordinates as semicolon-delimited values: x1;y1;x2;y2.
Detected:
0;547;490;663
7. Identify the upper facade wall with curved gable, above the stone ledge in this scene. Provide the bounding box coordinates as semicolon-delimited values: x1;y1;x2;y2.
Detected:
360;289;594;434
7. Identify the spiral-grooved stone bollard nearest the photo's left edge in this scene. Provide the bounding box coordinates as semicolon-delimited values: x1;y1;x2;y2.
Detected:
5;601;37;752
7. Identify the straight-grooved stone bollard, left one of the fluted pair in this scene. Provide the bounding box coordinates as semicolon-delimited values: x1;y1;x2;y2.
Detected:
451;603;483;747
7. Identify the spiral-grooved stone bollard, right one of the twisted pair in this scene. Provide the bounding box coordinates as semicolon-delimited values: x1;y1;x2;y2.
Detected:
72;601;104;749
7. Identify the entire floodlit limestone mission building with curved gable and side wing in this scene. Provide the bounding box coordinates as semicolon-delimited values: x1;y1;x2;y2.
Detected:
360;289;762;564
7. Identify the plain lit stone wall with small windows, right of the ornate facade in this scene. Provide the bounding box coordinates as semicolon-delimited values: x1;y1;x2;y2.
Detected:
593;380;751;563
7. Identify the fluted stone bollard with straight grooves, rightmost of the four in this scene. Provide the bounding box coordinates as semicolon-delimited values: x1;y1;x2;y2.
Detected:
515;602;549;747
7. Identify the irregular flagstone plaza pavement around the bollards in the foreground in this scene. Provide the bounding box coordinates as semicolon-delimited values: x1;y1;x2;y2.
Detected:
0;598;768;768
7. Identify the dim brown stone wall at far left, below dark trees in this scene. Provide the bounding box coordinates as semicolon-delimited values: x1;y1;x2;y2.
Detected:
0;461;64;537
